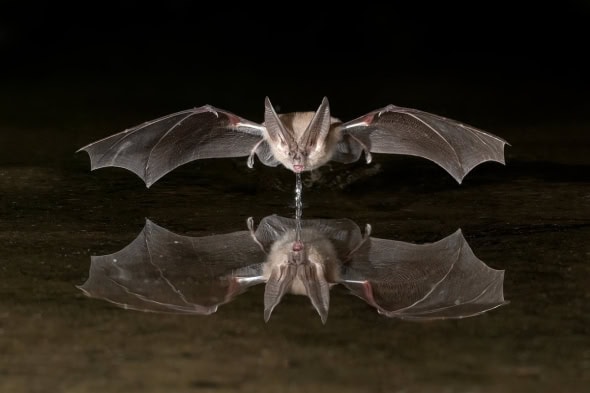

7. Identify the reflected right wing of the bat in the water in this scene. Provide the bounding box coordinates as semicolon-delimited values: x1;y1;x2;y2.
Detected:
342;230;506;320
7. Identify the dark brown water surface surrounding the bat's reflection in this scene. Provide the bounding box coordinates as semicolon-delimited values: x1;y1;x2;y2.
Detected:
0;82;590;393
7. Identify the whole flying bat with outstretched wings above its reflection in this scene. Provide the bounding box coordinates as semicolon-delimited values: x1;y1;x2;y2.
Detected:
78;97;507;187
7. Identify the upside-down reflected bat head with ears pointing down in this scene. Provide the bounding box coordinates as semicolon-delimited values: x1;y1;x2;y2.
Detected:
264;241;330;323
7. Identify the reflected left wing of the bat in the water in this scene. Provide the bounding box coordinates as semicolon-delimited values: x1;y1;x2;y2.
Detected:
78;220;265;315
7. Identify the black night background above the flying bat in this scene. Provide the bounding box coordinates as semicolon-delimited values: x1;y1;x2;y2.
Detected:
0;1;590;163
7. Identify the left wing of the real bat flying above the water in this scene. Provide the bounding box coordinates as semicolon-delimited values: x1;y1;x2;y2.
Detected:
78;105;278;187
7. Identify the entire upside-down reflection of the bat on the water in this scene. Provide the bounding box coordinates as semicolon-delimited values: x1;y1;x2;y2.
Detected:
78;215;507;323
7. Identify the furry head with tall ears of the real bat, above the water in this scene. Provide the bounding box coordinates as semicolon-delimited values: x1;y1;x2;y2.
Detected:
264;97;332;173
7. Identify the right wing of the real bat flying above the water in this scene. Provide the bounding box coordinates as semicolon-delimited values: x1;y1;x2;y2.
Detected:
333;105;507;183
